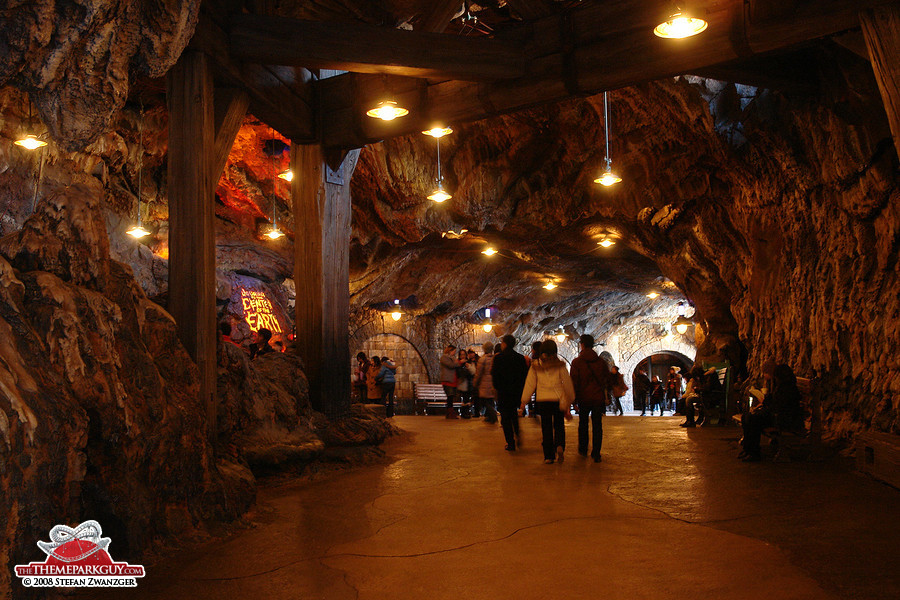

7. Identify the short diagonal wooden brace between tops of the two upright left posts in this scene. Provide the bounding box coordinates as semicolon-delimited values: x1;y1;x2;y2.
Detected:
189;15;315;143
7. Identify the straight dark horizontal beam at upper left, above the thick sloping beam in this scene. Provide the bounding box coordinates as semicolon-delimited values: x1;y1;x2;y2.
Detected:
228;14;525;81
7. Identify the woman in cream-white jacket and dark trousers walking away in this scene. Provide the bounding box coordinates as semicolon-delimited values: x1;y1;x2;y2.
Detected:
519;340;575;465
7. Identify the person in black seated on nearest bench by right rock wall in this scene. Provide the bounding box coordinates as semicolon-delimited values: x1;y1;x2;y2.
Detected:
738;364;803;462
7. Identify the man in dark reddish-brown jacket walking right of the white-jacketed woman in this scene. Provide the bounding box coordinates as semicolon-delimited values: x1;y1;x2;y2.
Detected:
570;334;613;462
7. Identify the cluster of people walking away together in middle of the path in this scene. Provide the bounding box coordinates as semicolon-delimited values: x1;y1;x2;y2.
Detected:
441;335;627;464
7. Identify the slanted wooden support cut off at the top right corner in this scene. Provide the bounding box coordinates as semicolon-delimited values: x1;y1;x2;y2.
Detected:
859;3;900;155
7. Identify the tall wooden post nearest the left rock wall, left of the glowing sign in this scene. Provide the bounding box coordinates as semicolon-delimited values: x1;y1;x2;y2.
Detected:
166;51;216;441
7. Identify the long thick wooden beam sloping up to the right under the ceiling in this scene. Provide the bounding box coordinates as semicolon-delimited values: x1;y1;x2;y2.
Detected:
316;0;892;148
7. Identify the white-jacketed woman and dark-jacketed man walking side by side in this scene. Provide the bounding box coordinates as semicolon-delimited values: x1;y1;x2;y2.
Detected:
519;334;613;464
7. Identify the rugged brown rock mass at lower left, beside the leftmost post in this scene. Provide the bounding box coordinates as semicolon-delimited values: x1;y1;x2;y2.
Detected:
0;177;255;589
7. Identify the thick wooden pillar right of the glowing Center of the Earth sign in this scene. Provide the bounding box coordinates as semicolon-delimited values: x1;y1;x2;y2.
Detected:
291;145;359;417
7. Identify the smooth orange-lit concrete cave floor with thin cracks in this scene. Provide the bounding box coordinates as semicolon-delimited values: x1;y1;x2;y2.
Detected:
109;417;900;600
